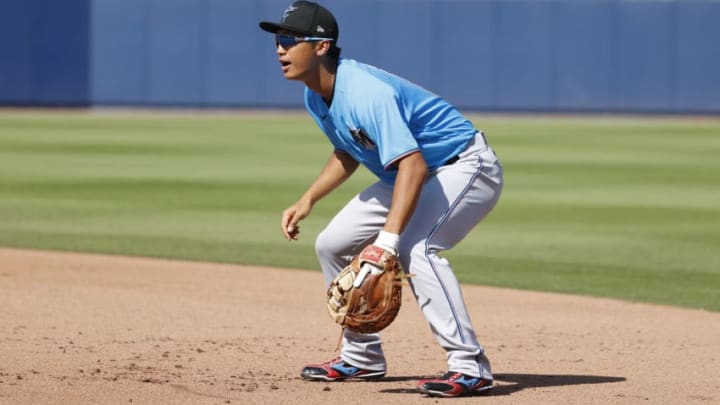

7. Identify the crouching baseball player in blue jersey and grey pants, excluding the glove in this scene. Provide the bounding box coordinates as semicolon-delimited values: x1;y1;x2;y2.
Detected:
260;1;503;397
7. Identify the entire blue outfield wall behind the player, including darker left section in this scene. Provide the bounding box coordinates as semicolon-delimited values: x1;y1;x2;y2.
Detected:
0;0;720;114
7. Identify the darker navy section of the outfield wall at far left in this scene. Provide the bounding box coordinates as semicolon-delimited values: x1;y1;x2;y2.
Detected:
0;0;91;106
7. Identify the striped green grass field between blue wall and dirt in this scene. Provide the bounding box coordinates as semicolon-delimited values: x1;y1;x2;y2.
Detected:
0;112;720;311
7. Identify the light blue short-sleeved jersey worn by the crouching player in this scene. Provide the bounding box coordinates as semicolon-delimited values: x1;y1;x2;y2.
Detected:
305;58;477;184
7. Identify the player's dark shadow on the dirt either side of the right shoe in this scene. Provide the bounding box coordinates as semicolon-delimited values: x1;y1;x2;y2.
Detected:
380;374;626;396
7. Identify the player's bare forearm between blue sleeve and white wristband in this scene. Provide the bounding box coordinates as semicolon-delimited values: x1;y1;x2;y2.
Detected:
383;152;427;235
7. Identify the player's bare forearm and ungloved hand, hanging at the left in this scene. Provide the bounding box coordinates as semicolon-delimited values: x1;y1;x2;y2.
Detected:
280;151;359;240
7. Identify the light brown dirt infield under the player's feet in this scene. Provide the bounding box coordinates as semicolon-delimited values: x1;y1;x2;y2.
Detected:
0;249;720;405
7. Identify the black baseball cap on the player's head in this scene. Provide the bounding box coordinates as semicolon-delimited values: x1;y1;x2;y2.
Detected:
260;1;340;42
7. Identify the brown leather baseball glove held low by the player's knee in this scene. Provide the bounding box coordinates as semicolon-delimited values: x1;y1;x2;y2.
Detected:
327;245;409;333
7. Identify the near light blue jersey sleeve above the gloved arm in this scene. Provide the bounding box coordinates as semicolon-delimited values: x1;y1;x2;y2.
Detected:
356;88;420;170
